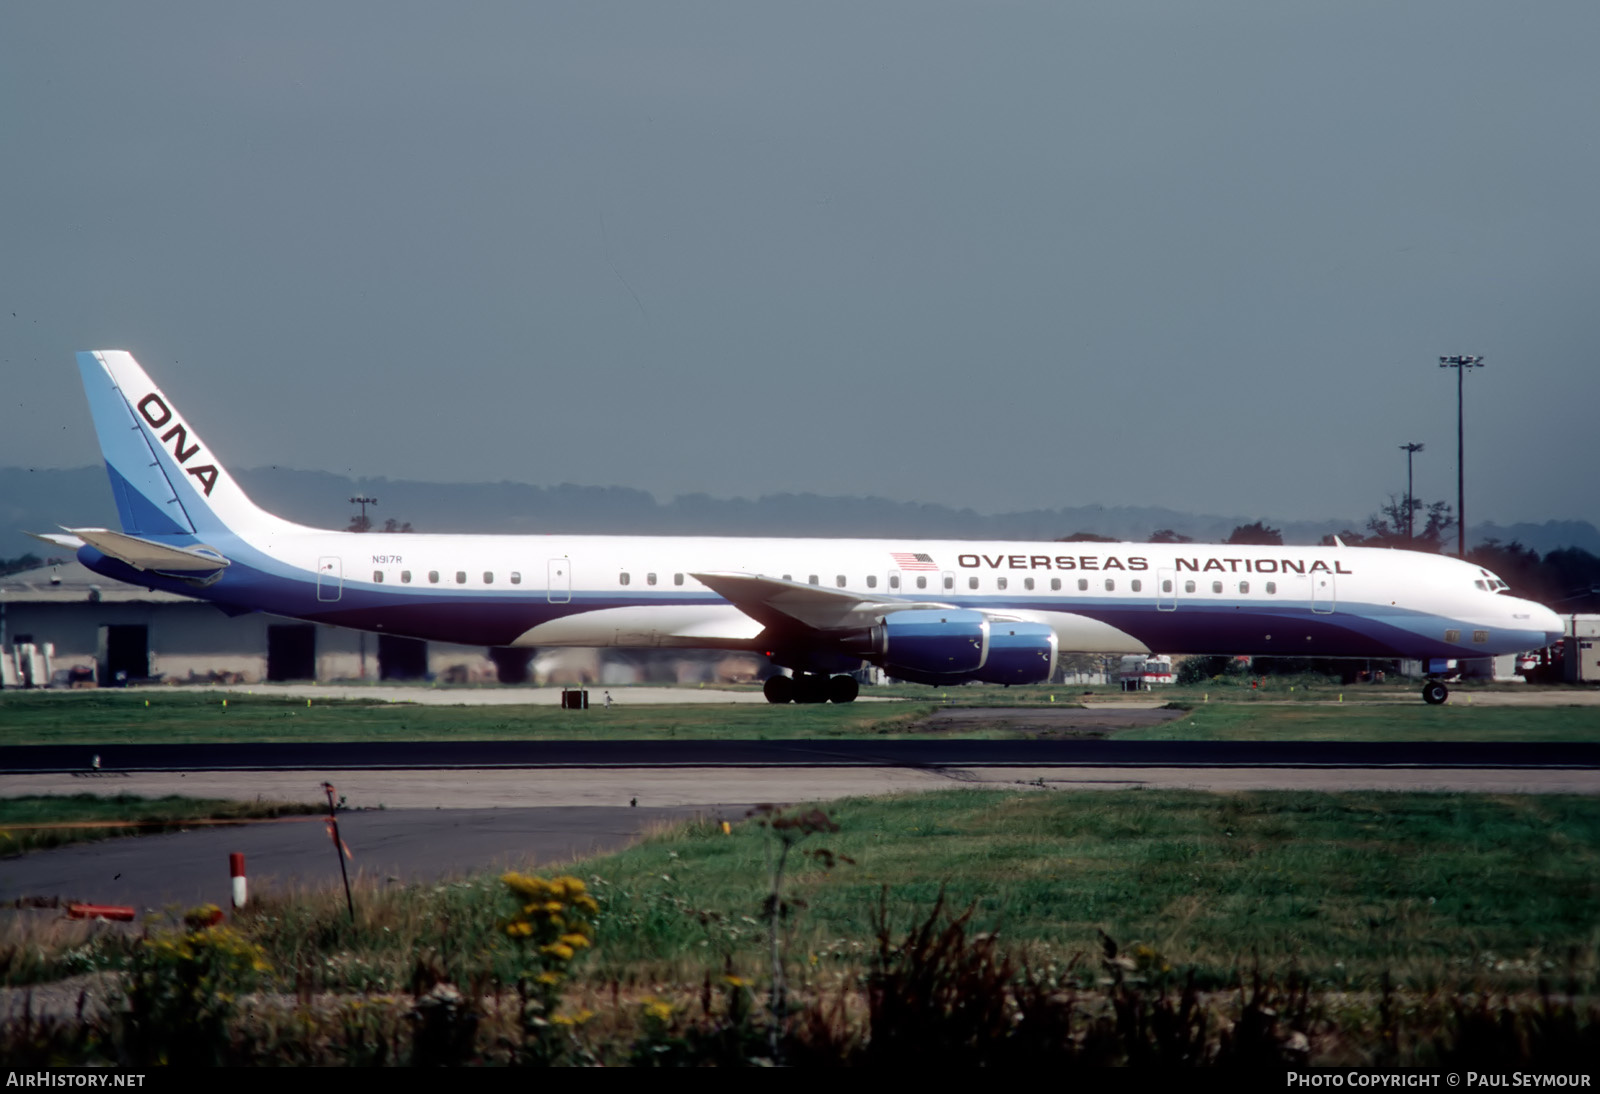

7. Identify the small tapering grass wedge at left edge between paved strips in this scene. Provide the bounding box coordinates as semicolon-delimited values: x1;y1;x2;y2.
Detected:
0;793;326;857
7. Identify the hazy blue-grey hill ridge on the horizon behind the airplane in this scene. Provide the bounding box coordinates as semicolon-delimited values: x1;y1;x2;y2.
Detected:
0;467;1600;558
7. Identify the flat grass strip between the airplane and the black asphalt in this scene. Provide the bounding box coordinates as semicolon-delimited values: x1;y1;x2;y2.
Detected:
0;688;1600;744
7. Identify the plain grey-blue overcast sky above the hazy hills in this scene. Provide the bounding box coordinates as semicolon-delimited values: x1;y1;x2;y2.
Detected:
0;0;1600;523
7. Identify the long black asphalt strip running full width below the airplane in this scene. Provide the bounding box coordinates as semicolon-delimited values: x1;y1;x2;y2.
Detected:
0;739;1600;774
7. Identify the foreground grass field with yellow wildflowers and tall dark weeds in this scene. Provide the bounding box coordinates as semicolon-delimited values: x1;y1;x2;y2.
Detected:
0;790;1600;1067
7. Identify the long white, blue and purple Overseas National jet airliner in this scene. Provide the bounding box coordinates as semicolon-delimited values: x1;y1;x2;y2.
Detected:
38;350;1562;704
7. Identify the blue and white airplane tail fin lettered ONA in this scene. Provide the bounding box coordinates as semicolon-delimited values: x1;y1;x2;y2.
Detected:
78;350;308;536
